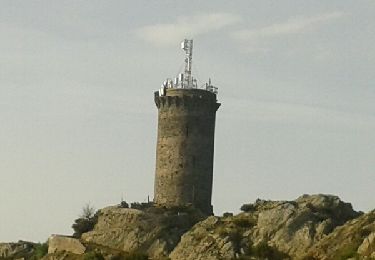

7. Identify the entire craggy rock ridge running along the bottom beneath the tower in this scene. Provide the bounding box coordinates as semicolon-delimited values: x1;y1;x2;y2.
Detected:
0;195;375;260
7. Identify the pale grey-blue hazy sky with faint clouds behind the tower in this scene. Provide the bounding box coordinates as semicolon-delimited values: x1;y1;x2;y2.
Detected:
0;0;375;242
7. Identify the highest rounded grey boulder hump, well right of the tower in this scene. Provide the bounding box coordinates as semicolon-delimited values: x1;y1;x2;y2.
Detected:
250;195;359;257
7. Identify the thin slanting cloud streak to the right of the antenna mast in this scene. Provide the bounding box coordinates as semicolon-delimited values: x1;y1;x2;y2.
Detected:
232;11;345;51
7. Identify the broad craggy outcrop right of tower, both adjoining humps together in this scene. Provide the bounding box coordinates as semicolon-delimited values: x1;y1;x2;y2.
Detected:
170;195;359;260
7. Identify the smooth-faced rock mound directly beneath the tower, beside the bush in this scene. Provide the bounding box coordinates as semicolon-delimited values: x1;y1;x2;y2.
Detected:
82;206;200;258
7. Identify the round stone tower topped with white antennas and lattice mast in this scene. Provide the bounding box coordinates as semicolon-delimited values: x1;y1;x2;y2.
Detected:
154;40;220;214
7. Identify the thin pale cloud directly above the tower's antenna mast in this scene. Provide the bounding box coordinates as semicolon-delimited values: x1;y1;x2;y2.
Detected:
136;13;241;46
